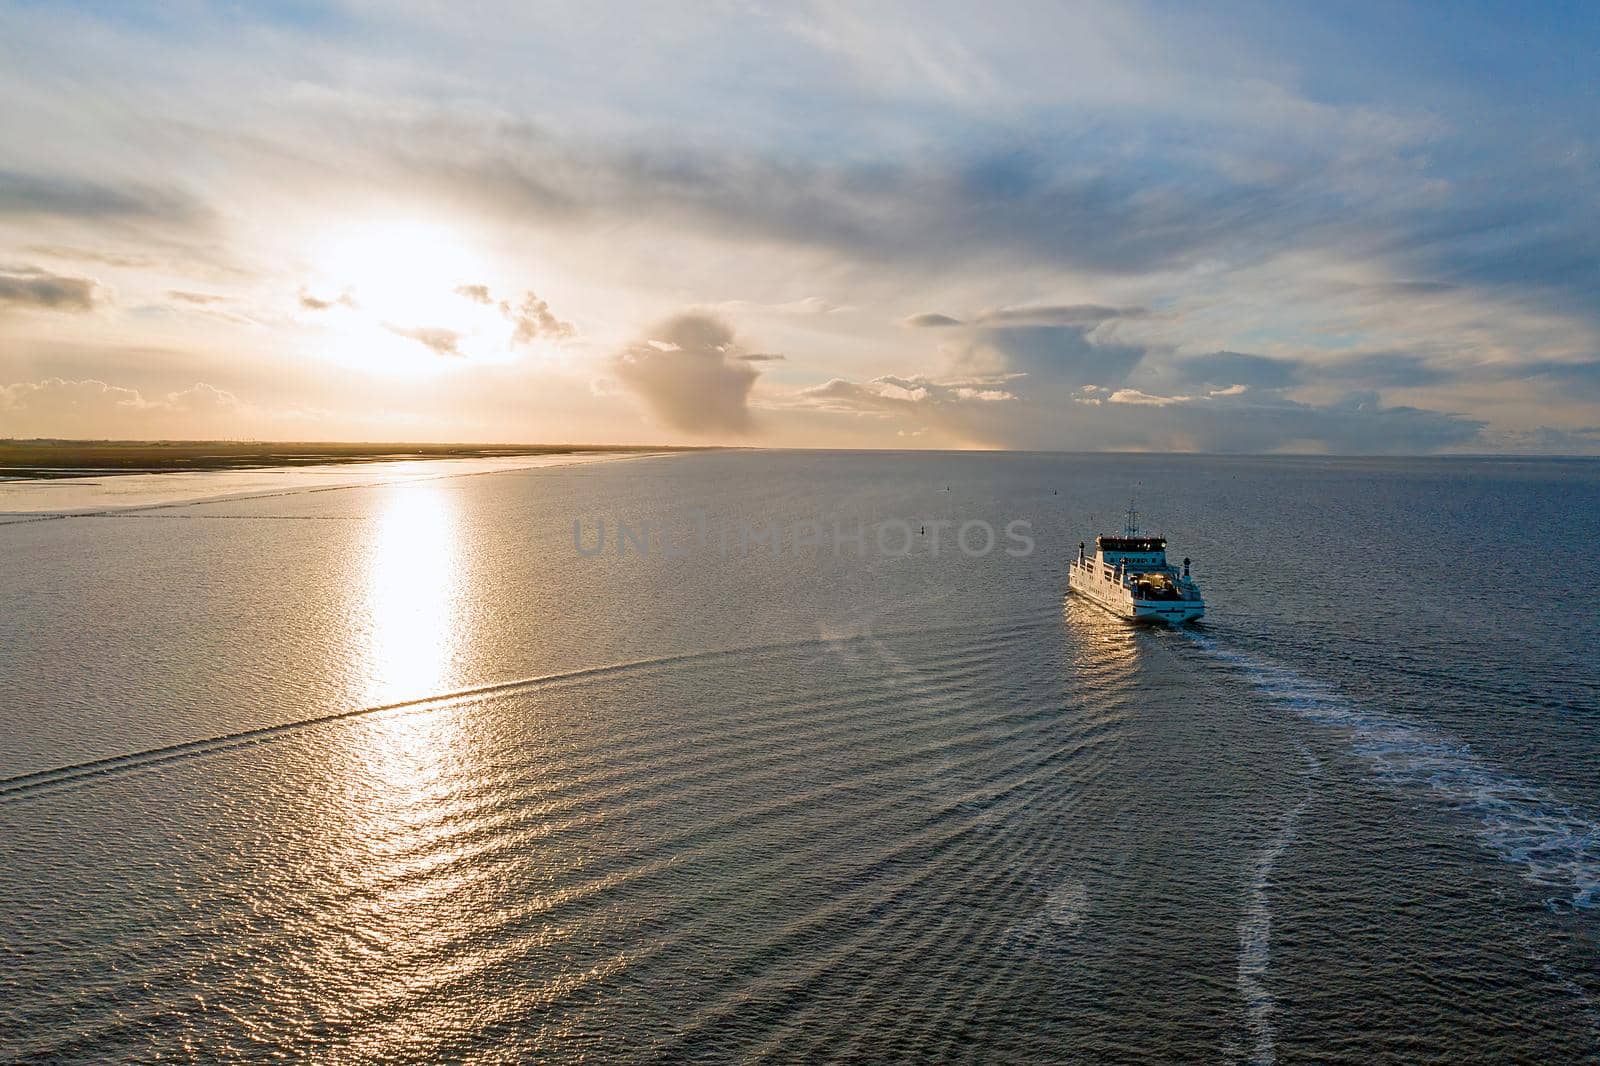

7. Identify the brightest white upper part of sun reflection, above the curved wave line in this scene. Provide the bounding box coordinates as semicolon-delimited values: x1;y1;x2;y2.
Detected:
366;482;462;704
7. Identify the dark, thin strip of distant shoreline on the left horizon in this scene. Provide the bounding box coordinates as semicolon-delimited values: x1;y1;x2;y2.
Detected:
0;440;702;480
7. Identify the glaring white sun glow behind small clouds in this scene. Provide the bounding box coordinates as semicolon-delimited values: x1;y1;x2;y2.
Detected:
301;221;514;376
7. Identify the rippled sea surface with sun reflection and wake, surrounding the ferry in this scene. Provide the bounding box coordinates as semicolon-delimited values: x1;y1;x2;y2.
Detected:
0;453;1600;1063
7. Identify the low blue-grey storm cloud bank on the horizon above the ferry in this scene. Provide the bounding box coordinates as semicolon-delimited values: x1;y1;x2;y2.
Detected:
825;306;1485;453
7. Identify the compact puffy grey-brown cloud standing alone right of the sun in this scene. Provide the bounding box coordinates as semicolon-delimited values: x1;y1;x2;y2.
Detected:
611;312;758;435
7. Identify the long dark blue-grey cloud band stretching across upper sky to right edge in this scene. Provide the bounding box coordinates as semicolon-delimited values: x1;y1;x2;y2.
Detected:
356;96;1600;422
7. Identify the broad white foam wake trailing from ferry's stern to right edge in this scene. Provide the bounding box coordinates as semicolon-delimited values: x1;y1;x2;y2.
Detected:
1190;634;1600;909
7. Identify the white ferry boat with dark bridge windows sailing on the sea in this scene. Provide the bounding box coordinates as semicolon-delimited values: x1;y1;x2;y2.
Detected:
1067;506;1205;626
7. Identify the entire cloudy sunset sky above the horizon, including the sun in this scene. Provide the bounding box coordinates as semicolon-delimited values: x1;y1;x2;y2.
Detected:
0;0;1600;455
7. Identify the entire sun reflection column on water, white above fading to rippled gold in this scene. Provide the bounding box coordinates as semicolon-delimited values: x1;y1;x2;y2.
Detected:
288;482;482;1043
